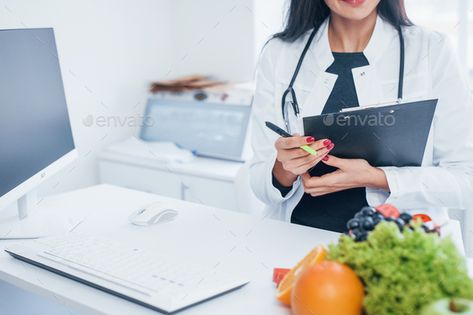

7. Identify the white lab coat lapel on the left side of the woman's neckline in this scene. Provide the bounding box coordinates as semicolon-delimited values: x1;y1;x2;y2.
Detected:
302;19;338;116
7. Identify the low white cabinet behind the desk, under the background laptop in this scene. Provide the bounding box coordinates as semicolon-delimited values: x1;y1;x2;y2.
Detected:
98;150;264;213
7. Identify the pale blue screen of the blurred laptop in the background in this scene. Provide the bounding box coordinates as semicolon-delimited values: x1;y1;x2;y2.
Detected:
141;98;251;160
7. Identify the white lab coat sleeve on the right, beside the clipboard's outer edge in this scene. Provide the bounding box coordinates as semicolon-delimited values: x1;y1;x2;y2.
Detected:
383;33;473;209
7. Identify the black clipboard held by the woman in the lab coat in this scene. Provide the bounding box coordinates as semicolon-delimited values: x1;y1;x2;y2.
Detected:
303;99;438;167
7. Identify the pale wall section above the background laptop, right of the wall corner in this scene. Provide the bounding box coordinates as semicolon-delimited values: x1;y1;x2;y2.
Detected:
169;0;256;81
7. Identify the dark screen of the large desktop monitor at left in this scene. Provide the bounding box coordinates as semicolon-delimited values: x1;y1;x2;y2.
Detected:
0;28;74;198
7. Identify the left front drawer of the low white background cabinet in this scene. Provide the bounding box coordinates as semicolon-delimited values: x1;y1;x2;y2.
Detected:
99;160;182;199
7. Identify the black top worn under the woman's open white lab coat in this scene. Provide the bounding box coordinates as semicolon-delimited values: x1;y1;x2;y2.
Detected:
273;52;369;232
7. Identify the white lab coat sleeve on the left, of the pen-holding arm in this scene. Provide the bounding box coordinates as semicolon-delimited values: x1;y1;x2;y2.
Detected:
250;39;300;208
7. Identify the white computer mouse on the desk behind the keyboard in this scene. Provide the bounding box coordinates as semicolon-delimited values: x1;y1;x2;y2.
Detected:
129;203;179;226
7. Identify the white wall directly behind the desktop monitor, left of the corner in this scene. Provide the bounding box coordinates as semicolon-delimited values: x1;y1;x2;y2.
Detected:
0;0;172;196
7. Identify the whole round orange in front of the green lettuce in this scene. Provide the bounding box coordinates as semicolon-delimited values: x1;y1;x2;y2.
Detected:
291;261;365;315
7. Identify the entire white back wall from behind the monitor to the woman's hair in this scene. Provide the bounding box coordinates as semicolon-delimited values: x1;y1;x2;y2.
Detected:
0;0;285;198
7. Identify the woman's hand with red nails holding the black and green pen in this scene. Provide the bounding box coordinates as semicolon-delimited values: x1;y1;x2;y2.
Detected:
273;135;334;187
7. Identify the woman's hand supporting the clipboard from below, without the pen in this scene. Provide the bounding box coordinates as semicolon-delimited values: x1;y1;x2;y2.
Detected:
302;155;389;197
